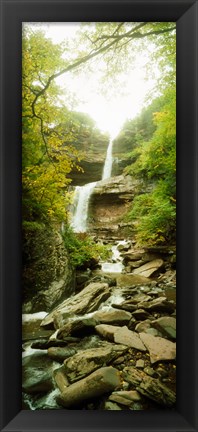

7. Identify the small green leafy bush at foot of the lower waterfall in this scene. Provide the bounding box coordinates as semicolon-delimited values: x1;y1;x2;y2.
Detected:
62;225;109;268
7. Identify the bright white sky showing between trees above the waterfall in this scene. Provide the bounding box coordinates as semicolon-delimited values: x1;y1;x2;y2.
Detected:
25;22;158;138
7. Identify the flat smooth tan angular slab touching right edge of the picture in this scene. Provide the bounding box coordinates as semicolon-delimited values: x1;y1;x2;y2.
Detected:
139;333;176;364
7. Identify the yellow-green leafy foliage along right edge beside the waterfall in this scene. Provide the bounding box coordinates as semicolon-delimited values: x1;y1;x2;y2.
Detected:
126;89;176;244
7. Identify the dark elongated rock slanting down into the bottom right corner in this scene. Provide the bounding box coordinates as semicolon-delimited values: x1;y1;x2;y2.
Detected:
123;367;176;407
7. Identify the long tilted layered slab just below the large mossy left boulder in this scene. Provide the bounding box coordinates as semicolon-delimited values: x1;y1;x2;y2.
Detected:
41;282;111;326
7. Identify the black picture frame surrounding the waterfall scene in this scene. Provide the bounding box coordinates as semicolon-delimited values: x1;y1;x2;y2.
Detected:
0;0;198;432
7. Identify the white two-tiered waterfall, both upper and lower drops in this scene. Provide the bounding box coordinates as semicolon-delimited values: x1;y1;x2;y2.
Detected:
70;139;113;232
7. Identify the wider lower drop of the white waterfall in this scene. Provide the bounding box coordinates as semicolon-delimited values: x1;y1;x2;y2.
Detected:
71;182;96;232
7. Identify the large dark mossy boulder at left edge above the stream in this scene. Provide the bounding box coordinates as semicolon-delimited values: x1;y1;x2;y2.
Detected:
22;226;75;313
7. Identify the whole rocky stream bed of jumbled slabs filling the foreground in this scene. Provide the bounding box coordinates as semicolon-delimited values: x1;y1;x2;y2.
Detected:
23;244;176;410
